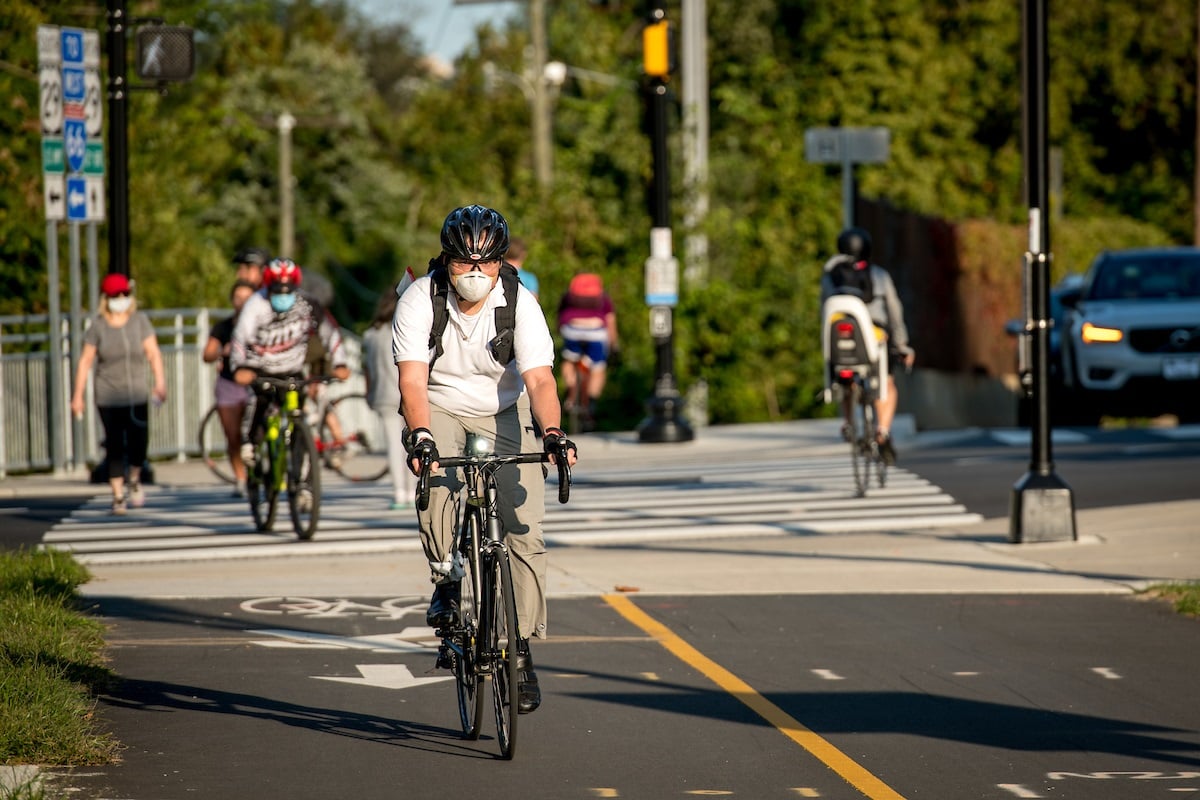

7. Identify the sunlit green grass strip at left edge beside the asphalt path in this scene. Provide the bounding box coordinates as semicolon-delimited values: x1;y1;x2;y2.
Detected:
0;549;118;767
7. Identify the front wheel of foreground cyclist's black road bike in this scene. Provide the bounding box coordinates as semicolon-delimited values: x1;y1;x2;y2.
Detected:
487;547;521;758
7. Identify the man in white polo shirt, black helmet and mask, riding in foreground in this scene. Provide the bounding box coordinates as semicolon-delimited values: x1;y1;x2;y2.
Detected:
392;205;576;714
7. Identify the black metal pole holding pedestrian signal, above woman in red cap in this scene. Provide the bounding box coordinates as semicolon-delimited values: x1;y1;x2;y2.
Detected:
106;0;130;275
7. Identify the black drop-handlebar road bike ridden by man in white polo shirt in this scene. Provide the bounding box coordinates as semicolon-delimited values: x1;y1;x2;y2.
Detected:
416;434;571;759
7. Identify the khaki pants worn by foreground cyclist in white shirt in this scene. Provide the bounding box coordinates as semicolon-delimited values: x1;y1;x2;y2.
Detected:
418;397;546;638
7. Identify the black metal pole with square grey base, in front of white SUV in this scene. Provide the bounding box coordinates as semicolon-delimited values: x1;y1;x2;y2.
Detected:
1009;0;1075;542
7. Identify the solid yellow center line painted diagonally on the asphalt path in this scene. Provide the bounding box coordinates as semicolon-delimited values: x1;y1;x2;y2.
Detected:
604;595;904;800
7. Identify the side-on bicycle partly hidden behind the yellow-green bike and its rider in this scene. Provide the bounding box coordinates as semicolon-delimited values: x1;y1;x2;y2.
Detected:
198;393;388;483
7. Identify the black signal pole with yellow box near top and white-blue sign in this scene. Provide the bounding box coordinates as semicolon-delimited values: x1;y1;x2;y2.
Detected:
637;0;695;441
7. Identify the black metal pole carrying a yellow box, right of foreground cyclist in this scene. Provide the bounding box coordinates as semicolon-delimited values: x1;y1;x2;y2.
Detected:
637;0;695;443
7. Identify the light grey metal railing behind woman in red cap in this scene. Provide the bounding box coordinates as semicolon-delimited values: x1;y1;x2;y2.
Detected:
0;308;364;479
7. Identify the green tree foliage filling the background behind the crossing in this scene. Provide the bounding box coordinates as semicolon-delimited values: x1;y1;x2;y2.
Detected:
0;0;1196;427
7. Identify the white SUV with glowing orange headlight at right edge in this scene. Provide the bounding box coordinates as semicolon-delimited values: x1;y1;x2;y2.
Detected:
1062;247;1200;417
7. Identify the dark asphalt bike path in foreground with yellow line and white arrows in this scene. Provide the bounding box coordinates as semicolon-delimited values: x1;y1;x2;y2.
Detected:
46;595;1200;800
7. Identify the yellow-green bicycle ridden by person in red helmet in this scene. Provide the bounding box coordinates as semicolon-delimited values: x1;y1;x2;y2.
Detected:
246;375;336;541
